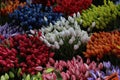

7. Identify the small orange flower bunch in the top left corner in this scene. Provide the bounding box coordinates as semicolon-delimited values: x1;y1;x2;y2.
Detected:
0;0;26;15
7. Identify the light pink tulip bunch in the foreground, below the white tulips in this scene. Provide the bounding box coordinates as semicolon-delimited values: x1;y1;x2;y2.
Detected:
42;56;103;80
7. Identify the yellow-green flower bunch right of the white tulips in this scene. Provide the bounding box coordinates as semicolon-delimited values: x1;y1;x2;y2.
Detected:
77;2;120;30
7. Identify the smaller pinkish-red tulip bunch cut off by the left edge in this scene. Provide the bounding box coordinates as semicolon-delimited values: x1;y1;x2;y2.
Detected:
0;45;18;73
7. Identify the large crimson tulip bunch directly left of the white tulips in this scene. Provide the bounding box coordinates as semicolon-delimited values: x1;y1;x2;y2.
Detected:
4;33;54;74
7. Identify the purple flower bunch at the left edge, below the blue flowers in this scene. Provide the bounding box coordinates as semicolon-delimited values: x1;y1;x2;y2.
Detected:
0;23;24;38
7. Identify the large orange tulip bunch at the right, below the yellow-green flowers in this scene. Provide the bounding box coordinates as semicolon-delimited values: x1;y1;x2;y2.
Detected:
83;31;120;59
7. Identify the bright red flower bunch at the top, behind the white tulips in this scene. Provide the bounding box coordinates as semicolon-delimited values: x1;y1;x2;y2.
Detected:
54;0;92;15
